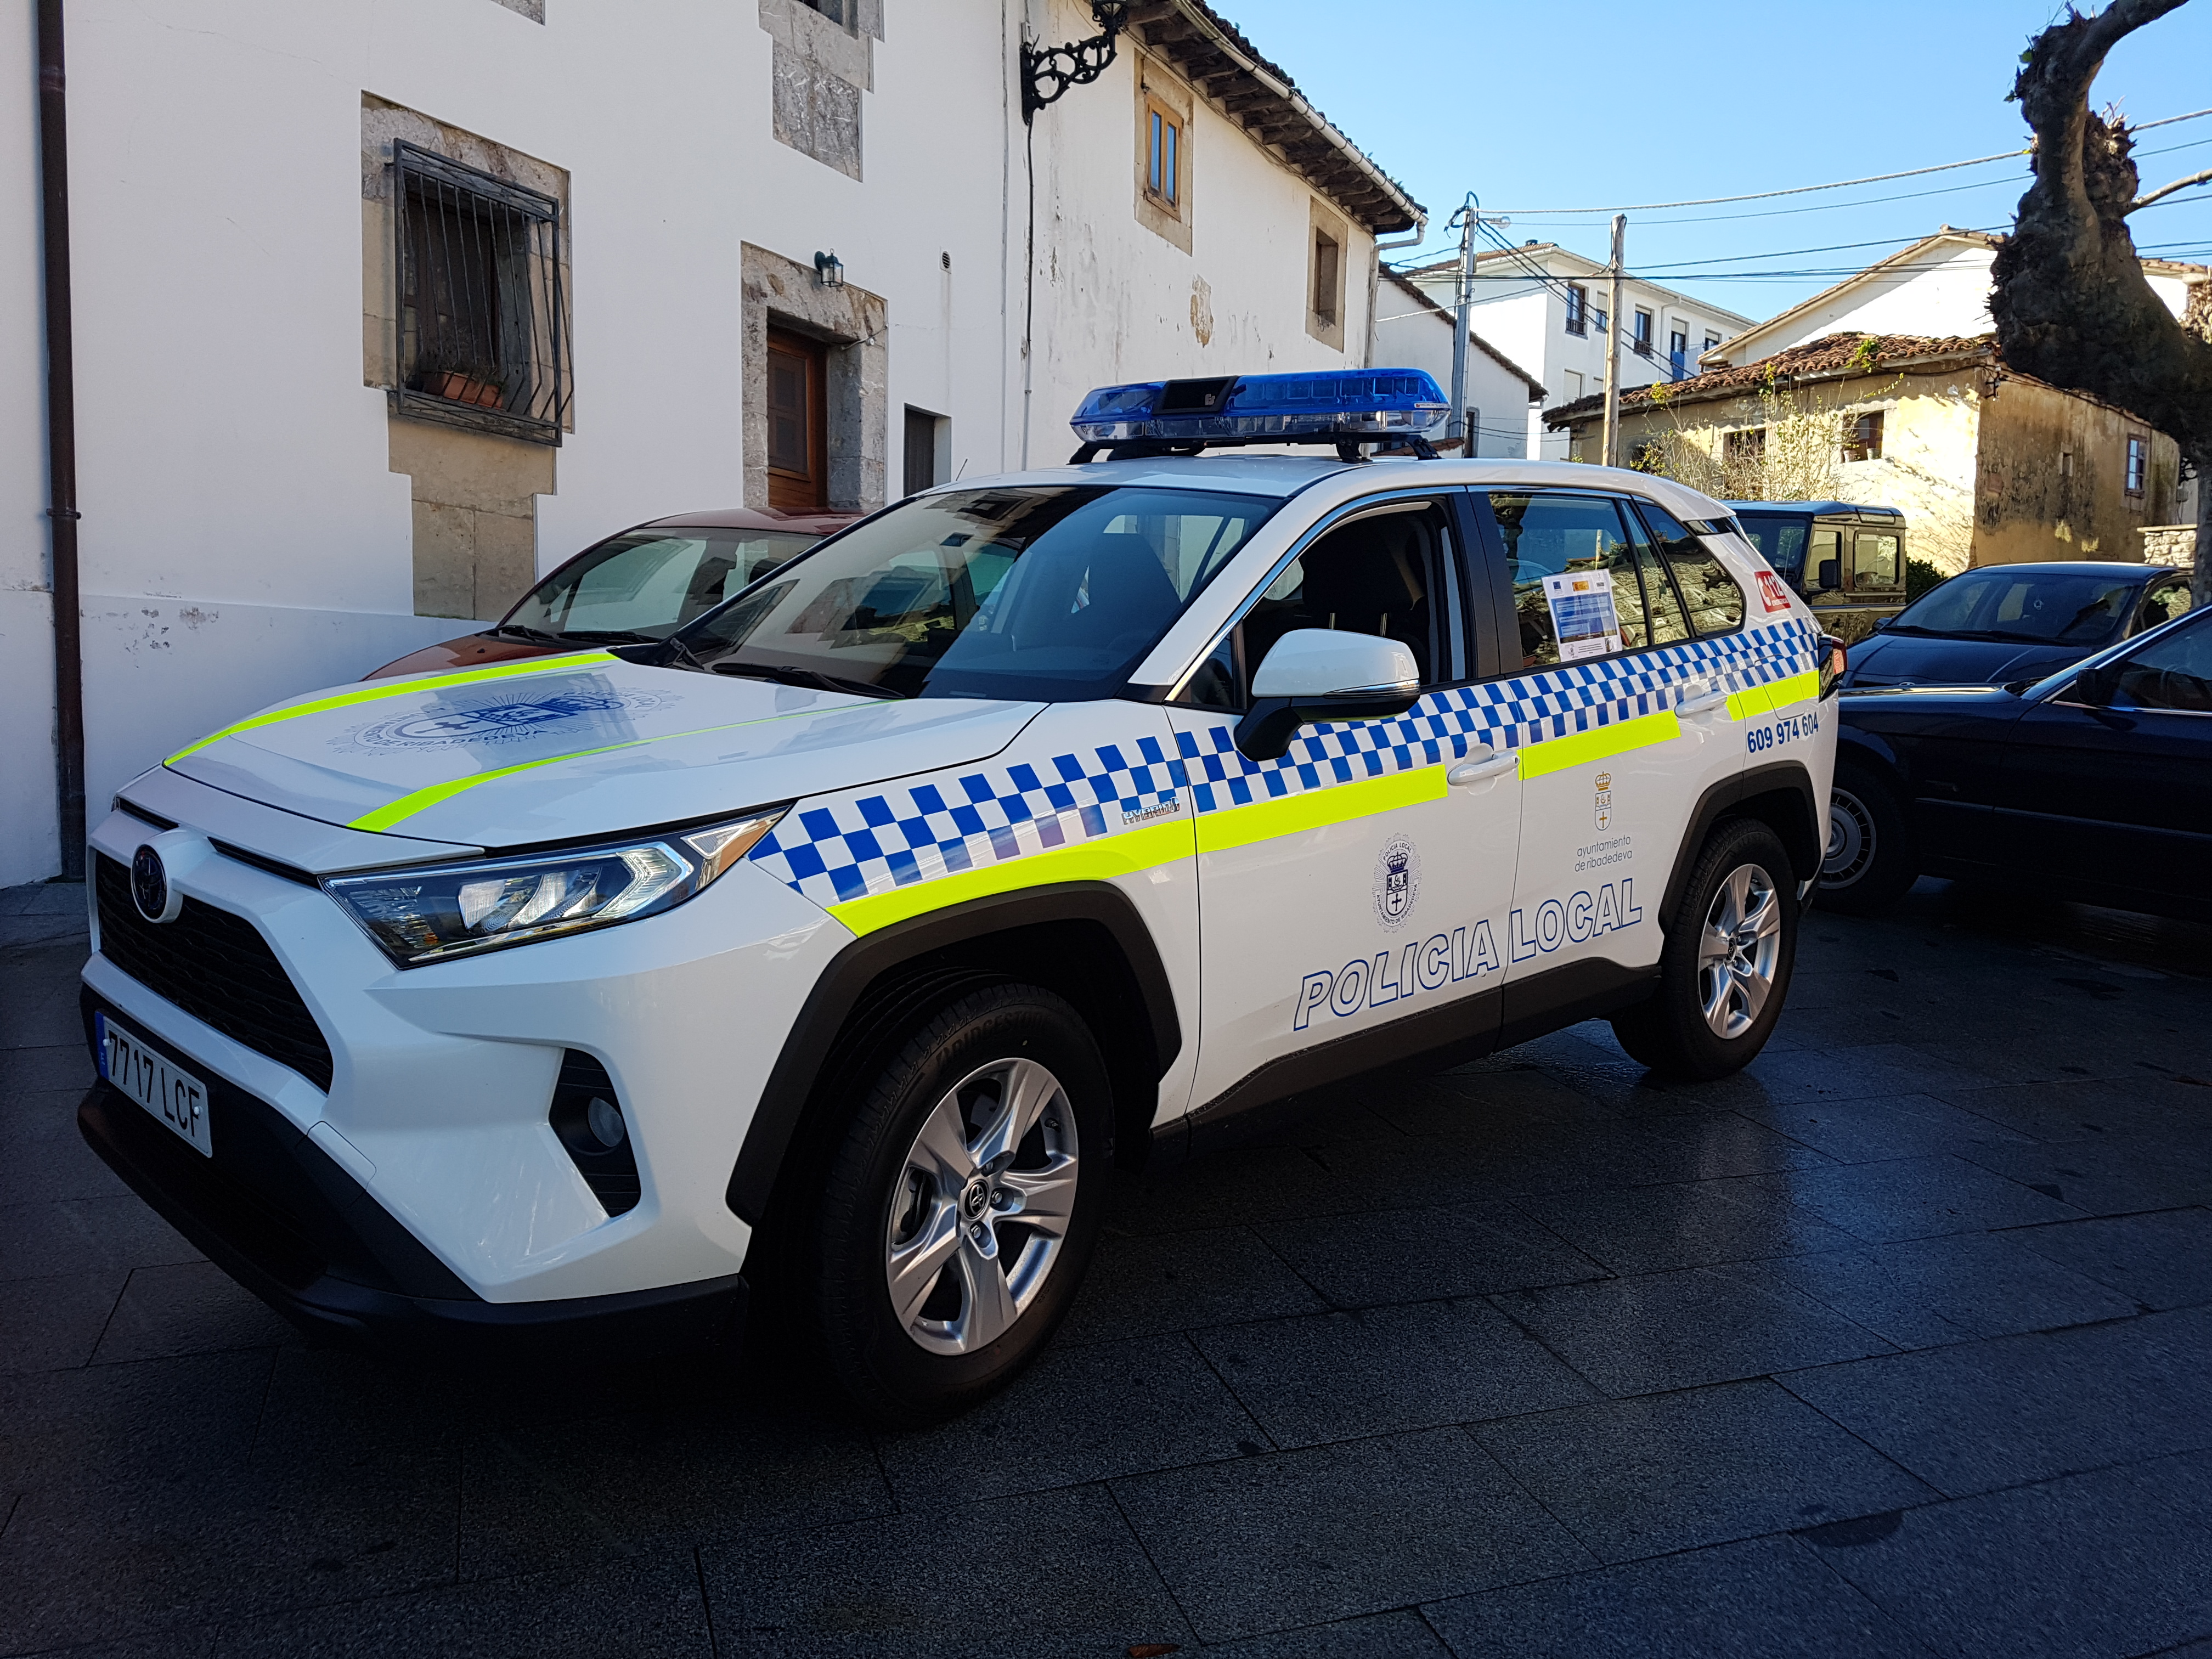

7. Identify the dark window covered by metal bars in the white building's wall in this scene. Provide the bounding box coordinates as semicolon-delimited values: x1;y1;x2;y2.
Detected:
392;142;568;444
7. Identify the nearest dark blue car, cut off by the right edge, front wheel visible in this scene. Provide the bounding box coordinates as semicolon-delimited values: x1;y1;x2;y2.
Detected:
1820;611;2212;920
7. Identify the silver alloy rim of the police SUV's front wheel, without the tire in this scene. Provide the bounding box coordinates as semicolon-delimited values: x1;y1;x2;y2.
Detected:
883;1059;1080;1354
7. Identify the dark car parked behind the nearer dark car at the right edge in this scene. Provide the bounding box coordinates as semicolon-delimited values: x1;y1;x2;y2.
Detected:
1843;560;2190;688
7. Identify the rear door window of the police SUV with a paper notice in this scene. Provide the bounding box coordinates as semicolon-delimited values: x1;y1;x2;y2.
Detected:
1489;489;1646;668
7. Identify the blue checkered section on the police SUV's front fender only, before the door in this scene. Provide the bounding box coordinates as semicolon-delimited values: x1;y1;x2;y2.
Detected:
752;737;1183;907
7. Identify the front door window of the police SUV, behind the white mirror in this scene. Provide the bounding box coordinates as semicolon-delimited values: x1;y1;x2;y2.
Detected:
1179;502;1462;708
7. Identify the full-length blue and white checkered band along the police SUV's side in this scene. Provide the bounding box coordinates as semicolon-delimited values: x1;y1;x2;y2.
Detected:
752;619;1818;907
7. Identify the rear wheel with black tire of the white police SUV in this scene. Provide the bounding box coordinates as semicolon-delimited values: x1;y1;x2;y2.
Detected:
1612;819;1798;1080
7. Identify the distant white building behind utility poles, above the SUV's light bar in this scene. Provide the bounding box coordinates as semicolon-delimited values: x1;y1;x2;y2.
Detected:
1407;241;1750;460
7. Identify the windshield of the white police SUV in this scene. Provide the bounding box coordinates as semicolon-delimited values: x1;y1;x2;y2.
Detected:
679;484;1281;701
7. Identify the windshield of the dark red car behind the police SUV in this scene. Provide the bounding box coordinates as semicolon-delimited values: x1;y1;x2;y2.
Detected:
500;529;821;639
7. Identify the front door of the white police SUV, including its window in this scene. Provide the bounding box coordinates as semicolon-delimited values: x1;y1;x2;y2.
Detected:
1168;491;1522;1119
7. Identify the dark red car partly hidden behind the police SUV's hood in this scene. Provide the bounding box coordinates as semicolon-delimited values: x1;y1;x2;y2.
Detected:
363;506;858;679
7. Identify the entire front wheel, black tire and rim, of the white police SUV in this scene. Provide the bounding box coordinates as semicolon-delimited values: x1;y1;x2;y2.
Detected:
805;982;1113;1425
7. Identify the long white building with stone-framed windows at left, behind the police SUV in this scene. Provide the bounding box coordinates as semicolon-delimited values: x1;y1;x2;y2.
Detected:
0;0;1420;885
